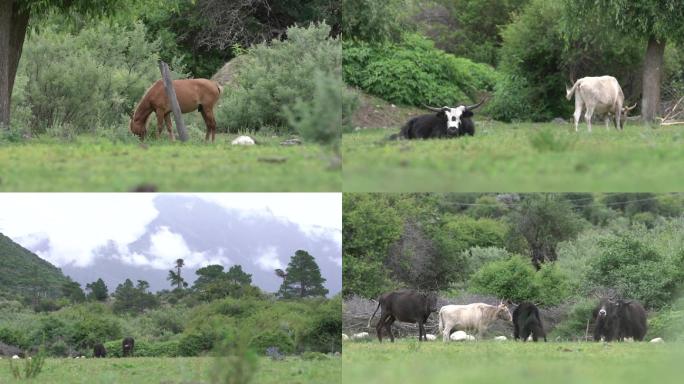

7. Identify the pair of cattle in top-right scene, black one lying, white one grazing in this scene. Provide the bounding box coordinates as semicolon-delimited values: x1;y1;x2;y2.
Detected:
389;76;636;140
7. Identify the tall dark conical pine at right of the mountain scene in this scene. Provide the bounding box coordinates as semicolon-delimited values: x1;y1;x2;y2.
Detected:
278;250;328;299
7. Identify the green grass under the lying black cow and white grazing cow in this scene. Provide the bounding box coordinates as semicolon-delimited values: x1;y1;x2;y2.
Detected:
342;121;684;192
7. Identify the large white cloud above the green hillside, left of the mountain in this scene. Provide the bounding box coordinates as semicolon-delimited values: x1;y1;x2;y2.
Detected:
0;193;159;266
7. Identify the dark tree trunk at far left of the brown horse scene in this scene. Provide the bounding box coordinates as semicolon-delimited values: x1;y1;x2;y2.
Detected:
0;0;29;128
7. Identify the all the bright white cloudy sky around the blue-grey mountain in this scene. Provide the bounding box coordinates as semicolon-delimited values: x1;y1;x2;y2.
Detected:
0;193;342;268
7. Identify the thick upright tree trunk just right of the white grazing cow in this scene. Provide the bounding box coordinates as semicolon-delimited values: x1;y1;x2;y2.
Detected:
641;36;665;123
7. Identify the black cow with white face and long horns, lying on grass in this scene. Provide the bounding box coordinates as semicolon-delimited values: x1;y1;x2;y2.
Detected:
390;99;485;140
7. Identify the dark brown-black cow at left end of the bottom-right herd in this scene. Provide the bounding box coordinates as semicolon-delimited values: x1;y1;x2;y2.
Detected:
368;290;437;342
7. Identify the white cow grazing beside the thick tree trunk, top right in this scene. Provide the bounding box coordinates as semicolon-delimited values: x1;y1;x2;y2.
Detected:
565;76;636;132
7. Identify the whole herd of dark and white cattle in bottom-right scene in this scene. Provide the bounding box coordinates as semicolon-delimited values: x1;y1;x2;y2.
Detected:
350;290;647;342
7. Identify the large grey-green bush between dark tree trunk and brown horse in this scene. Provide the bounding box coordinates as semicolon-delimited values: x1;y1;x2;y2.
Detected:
12;22;179;136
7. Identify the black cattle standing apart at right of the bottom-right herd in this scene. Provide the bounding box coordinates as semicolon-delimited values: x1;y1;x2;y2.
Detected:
593;298;647;341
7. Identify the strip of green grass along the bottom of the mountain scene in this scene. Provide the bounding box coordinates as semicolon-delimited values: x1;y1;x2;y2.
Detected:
0;357;341;384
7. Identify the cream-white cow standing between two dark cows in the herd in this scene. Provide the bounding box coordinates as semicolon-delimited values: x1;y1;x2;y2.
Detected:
439;302;513;342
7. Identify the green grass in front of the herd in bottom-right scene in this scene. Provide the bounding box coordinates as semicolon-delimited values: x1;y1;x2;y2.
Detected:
342;339;684;384
